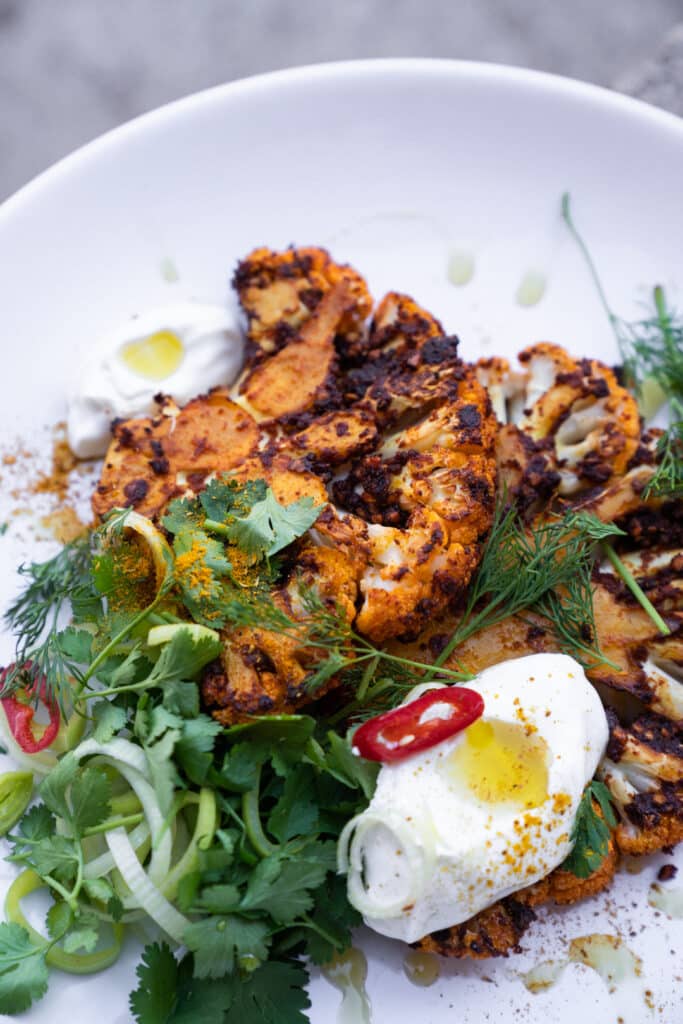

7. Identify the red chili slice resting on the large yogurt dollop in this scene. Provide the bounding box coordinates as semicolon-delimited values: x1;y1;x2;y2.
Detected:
353;686;483;763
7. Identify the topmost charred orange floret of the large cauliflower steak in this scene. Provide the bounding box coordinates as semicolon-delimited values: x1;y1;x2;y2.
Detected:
232;248;372;361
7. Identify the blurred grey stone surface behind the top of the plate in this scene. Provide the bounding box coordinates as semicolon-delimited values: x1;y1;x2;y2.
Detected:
0;0;683;200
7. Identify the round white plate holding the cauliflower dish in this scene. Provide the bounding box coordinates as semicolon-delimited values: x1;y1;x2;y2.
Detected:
0;60;683;1024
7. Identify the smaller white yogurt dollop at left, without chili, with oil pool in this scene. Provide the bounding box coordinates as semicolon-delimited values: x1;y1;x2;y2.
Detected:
68;302;244;459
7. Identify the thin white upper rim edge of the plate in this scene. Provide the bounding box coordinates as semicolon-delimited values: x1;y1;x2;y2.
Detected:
0;57;683;230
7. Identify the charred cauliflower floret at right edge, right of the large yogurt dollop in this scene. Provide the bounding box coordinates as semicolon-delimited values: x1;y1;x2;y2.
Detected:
598;713;683;855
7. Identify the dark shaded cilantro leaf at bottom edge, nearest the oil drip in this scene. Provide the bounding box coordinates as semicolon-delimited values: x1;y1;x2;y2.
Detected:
224;961;310;1024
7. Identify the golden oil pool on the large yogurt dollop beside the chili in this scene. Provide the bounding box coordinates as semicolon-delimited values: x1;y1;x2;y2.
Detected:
442;719;548;809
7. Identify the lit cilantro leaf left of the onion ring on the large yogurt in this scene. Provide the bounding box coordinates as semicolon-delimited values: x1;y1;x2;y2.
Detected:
241;857;327;925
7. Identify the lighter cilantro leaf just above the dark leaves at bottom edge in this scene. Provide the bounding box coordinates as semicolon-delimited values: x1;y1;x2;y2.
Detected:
184;913;270;978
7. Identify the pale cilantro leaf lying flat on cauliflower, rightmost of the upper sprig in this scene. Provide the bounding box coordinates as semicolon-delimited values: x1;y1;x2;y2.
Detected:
227;487;322;558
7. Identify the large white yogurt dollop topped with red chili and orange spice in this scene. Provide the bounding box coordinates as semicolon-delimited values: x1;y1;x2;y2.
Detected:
339;654;608;942
